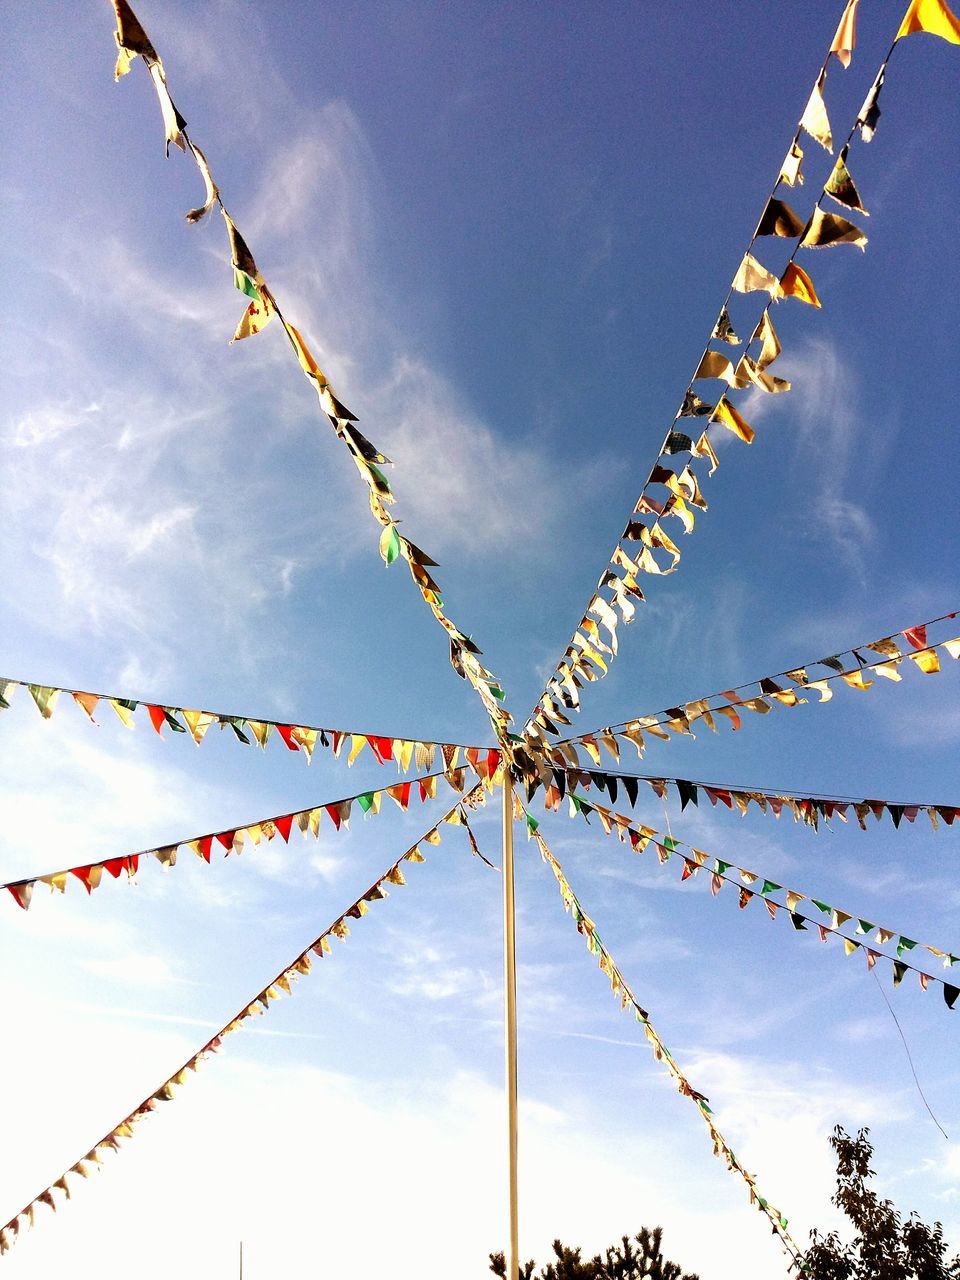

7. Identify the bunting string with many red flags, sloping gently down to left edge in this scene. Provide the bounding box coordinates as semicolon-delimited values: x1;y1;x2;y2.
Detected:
0;765;481;911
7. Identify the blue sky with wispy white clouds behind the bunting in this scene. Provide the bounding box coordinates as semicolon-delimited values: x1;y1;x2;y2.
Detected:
0;0;960;1280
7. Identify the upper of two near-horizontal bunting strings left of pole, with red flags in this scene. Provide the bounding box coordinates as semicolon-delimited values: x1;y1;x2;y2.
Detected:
0;678;500;777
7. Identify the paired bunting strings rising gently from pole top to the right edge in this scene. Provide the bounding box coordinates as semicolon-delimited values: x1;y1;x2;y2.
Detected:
547;613;960;768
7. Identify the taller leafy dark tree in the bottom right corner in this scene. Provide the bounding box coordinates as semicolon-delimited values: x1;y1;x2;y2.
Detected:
801;1125;960;1280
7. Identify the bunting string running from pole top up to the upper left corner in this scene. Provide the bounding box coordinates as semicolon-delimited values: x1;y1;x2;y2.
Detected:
113;0;511;753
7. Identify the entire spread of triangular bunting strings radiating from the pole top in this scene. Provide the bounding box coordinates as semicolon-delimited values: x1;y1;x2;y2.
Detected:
0;0;960;1270
